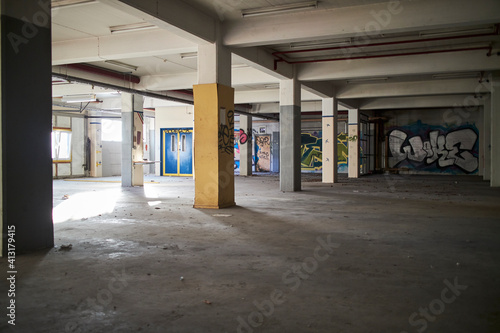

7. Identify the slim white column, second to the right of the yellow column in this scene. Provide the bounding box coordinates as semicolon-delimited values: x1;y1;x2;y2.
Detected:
322;98;338;183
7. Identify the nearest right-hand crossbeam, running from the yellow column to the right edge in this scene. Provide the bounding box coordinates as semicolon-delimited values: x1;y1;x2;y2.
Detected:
223;0;500;47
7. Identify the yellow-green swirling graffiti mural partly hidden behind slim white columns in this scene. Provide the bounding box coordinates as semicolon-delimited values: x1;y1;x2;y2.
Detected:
301;131;349;173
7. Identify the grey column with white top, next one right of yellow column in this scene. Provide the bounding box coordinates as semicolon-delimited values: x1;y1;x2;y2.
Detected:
280;79;302;192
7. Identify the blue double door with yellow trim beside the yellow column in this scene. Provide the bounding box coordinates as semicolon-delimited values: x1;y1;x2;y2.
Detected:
161;128;193;176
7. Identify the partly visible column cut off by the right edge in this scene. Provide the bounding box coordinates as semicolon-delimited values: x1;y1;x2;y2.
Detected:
490;73;500;187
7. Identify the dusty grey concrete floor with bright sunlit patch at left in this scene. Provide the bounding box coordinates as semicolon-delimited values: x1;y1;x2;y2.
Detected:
0;175;500;333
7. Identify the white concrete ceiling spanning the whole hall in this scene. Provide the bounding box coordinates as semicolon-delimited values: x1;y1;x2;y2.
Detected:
52;0;500;111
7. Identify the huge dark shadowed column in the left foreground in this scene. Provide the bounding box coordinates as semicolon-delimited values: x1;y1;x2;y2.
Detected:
0;1;54;254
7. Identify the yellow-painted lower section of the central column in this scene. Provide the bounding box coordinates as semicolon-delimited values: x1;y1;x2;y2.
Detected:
193;83;235;209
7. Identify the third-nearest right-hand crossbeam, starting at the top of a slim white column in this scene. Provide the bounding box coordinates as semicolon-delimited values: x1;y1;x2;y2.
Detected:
337;78;489;99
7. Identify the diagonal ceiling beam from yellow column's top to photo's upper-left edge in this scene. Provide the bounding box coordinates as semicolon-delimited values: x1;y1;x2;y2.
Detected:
101;0;218;44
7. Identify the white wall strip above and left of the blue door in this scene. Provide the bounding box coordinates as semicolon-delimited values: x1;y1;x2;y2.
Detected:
155;105;194;176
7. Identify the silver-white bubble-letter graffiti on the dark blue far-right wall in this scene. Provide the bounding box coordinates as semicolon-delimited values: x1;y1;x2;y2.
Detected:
388;122;479;174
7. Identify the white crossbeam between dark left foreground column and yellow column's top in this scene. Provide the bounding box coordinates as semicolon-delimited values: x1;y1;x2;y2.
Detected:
52;29;198;65
